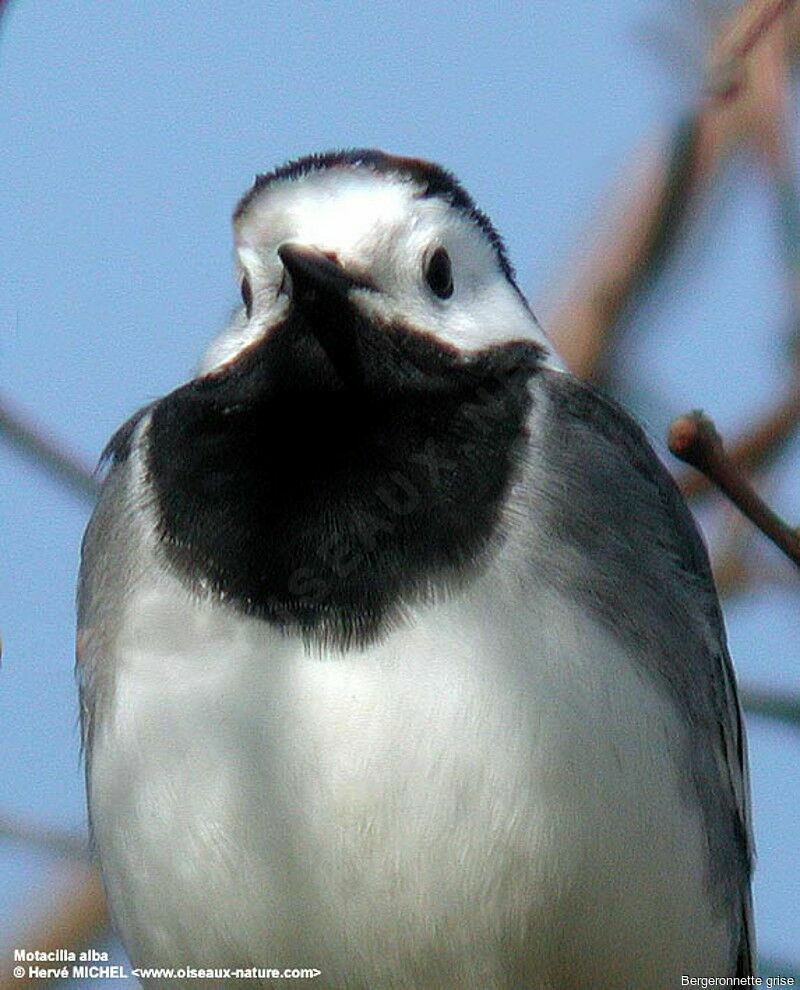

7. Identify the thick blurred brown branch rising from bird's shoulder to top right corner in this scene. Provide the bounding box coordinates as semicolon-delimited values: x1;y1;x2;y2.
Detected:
546;0;800;379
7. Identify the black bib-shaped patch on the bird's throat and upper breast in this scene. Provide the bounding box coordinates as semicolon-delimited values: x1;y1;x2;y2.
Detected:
147;310;541;646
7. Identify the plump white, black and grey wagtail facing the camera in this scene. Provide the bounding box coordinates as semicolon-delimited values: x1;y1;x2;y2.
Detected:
77;149;755;990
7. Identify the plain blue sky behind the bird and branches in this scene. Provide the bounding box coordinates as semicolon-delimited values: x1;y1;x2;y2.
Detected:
0;0;800;976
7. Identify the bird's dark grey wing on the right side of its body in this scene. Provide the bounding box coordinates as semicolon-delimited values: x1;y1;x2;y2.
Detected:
525;370;755;976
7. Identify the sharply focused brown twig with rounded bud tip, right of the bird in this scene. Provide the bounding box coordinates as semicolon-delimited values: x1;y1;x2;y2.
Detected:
668;412;800;567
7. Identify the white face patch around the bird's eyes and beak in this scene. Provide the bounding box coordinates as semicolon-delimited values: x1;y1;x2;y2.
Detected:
201;165;563;373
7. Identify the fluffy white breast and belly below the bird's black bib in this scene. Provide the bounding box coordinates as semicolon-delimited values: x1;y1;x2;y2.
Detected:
90;575;730;990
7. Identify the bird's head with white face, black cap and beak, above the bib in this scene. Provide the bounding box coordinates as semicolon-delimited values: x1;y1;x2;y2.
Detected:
202;150;557;383
